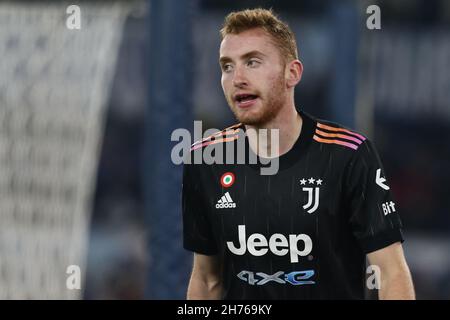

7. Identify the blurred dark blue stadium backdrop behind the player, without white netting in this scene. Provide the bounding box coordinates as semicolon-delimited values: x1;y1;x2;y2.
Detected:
0;0;450;299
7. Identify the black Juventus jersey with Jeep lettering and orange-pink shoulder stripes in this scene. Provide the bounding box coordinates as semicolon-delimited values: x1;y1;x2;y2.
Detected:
182;112;403;299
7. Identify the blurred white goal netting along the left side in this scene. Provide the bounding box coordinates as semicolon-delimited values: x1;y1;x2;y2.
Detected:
0;1;130;299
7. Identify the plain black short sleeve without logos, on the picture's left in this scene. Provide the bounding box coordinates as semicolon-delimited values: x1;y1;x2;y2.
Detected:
182;164;218;255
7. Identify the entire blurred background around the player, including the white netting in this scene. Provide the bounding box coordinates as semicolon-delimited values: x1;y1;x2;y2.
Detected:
0;0;450;299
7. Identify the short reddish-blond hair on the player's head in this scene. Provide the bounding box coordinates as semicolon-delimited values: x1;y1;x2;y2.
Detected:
220;8;298;62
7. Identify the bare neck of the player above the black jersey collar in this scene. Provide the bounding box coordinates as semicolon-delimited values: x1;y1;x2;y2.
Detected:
245;104;303;158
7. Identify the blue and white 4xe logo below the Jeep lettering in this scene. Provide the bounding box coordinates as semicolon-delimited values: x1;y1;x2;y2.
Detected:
237;270;316;286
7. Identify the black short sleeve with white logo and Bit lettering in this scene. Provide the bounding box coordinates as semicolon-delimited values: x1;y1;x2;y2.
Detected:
346;140;403;253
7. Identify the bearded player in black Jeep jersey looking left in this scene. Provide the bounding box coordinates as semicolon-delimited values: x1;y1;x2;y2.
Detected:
183;9;414;299
